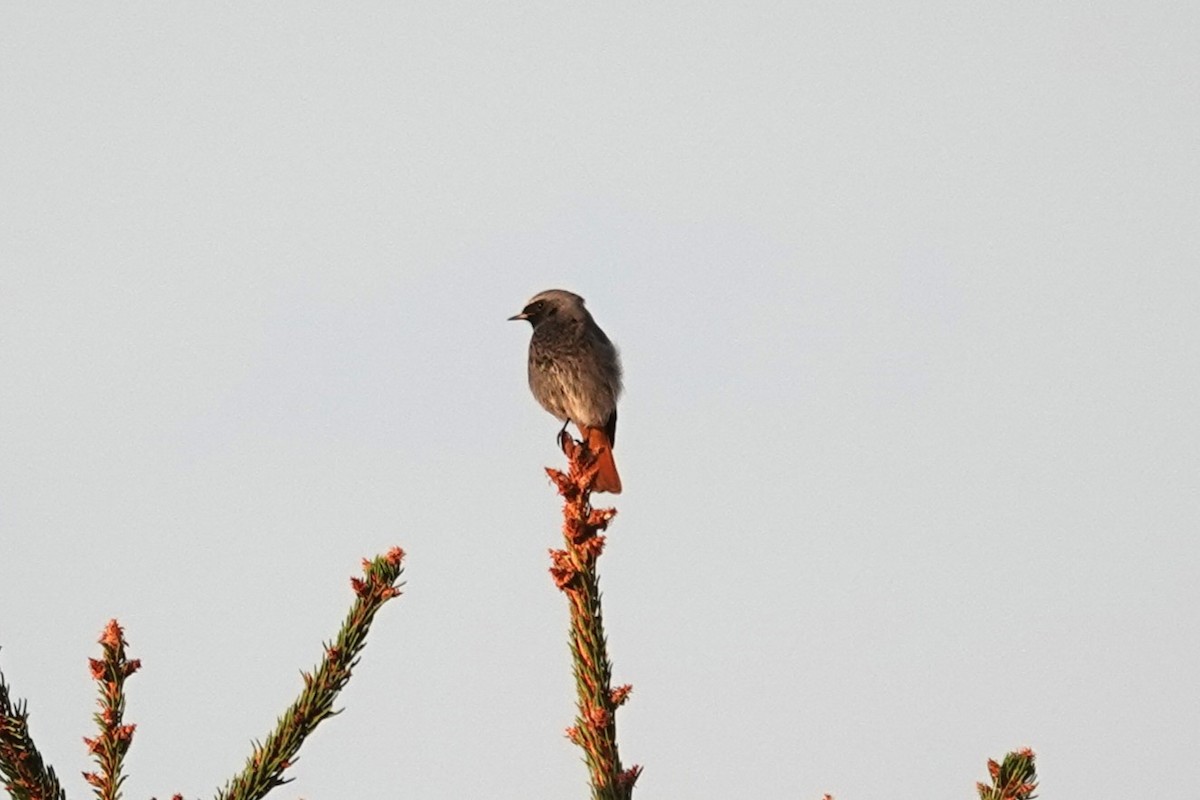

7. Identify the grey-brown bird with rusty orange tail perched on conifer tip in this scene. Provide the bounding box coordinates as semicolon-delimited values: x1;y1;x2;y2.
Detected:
509;289;622;494
